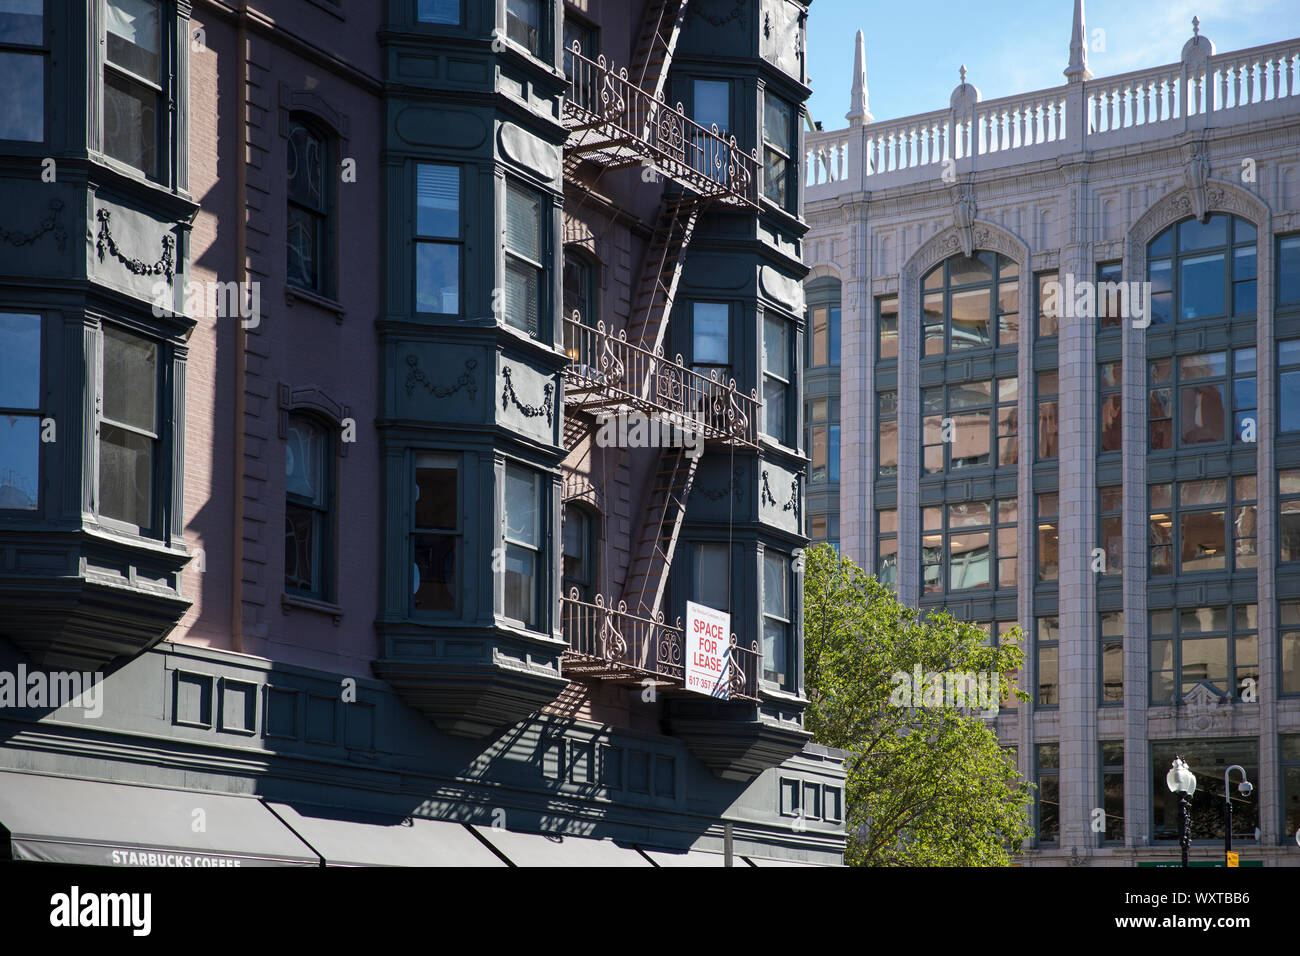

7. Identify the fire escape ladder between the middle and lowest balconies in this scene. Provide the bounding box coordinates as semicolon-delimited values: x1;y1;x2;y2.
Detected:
623;447;699;618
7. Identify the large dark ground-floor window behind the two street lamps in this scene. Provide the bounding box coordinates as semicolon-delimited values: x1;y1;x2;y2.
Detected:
1148;735;1253;842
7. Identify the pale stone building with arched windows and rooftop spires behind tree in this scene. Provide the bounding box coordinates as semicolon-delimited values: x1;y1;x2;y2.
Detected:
805;0;1300;865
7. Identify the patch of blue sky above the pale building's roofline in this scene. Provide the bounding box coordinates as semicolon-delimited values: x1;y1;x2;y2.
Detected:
807;0;1300;130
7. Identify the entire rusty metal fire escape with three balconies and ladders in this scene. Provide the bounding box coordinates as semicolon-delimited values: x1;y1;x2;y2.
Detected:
562;0;759;698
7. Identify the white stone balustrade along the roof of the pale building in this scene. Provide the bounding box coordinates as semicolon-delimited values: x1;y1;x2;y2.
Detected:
805;38;1300;199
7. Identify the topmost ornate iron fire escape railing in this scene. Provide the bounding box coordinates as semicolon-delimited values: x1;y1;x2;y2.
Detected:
564;40;759;208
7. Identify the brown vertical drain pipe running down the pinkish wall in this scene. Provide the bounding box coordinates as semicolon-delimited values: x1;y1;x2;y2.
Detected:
230;0;248;654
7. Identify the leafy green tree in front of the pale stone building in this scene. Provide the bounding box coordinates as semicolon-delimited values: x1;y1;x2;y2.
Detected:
803;545;1032;866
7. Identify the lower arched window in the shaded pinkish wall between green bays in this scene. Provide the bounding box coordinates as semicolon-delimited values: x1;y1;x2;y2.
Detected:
285;415;337;601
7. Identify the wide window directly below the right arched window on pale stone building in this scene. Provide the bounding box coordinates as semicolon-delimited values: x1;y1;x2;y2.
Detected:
1147;349;1258;451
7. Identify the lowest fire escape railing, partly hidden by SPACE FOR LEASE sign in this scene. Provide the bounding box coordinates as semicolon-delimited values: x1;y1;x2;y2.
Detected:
560;588;762;701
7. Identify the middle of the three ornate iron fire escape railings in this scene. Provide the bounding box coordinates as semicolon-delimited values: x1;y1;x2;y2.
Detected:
564;312;762;449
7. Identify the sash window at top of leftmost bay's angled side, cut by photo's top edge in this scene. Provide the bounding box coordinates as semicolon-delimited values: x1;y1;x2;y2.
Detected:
100;0;173;179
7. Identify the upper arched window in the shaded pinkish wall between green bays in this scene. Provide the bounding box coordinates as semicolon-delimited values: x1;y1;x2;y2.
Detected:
285;114;334;295
